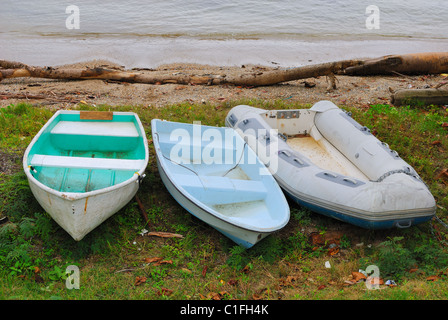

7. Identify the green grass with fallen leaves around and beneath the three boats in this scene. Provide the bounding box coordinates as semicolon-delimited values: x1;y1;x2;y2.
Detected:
0;100;448;300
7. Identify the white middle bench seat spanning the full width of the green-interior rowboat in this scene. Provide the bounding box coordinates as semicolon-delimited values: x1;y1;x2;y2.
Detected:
30;154;145;171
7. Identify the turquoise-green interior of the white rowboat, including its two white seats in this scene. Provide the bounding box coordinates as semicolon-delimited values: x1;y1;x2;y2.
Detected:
28;113;145;193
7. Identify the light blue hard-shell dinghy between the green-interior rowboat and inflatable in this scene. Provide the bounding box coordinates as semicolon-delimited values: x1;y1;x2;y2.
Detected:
151;119;290;248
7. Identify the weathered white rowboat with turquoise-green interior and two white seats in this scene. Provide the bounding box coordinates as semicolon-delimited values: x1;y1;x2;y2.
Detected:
23;110;148;241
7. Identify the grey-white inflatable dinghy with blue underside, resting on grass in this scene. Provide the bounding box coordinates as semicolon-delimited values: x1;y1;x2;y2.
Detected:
226;101;436;229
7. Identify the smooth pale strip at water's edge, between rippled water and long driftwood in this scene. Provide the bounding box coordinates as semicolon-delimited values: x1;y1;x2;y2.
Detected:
0;34;448;69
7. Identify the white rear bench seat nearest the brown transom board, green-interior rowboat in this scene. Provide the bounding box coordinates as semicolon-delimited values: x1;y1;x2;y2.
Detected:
51;121;138;137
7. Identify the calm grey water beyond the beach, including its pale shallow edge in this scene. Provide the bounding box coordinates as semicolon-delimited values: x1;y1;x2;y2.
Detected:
0;0;448;67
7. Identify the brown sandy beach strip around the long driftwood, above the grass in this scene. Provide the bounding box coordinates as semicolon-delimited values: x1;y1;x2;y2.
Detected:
0;60;444;108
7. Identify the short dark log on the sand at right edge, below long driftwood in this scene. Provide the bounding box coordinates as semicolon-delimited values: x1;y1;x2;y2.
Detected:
390;88;448;106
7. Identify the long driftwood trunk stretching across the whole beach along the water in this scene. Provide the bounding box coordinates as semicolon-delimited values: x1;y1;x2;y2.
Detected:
0;52;448;88
